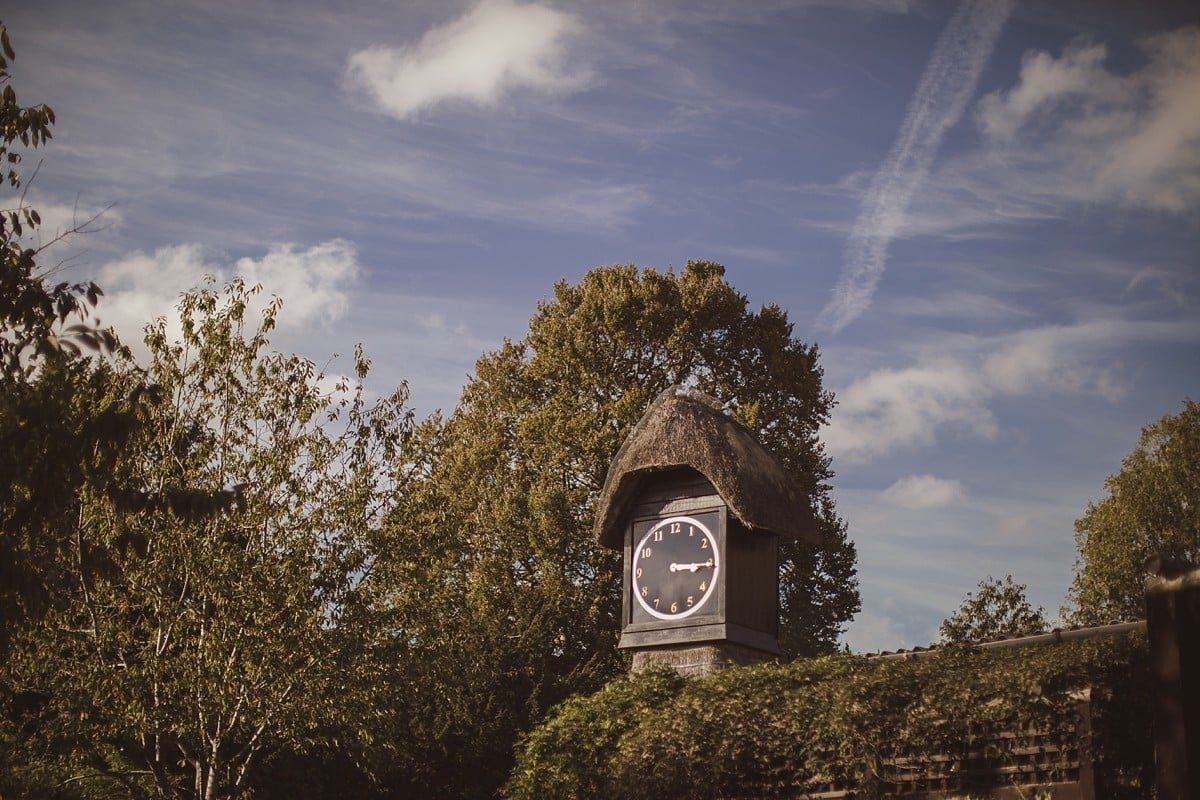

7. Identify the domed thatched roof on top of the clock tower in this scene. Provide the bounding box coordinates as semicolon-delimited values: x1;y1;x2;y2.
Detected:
595;386;820;548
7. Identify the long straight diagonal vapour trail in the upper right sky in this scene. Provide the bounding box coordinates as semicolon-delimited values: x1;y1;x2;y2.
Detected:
818;0;1013;332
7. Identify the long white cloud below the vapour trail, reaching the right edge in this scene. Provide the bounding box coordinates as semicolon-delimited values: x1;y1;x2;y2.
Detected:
823;319;1200;462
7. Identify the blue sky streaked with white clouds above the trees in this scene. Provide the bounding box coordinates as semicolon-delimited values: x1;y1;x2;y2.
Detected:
5;0;1200;650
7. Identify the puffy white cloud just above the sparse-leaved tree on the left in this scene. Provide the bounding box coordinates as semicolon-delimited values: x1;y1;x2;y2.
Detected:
96;239;359;357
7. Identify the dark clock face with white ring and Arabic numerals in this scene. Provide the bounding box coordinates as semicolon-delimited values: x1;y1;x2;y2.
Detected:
631;513;721;622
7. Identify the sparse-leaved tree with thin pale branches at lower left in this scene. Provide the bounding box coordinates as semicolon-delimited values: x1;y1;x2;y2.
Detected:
0;282;413;800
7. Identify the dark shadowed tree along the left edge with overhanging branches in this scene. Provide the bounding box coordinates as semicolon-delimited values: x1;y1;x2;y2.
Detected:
0;23;207;657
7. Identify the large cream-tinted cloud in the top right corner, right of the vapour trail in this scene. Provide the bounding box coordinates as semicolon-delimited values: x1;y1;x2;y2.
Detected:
950;28;1200;219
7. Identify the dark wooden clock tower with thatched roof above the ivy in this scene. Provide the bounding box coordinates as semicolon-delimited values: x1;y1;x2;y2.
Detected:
595;386;820;675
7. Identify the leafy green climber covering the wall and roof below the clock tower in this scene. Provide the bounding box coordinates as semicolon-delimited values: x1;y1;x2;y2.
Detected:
505;636;1150;800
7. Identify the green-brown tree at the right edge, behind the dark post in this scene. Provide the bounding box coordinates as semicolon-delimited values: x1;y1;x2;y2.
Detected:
1069;399;1200;624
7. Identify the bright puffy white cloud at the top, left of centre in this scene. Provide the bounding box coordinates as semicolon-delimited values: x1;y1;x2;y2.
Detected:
346;0;587;119
